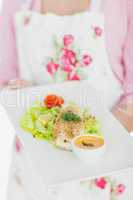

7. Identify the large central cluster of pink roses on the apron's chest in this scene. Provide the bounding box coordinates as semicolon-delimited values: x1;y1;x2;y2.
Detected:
45;34;93;81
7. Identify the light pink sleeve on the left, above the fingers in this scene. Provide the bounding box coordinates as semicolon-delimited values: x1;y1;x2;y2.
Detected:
0;0;20;86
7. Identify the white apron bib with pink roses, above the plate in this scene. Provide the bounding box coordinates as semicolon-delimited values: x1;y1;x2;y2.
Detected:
16;1;121;108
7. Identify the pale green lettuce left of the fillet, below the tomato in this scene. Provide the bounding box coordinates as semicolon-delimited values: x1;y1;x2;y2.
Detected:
20;101;59;142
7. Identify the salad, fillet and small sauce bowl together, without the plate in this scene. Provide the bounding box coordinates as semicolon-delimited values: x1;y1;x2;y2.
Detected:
20;94;105;164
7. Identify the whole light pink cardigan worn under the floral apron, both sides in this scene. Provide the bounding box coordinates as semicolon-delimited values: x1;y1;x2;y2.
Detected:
0;0;133;102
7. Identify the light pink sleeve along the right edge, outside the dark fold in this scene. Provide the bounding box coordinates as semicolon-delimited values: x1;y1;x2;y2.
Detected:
123;0;133;103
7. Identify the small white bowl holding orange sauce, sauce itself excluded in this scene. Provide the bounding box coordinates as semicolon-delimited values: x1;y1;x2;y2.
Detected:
72;135;106;164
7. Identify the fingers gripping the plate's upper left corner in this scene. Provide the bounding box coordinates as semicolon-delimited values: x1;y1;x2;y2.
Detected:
7;79;31;90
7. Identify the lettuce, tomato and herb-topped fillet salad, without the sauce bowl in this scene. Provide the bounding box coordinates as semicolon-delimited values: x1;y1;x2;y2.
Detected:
20;94;101;150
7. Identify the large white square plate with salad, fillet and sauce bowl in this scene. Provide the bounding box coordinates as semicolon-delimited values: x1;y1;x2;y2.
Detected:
1;83;133;188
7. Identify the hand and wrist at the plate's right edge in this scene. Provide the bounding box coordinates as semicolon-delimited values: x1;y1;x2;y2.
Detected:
112;104;133;132
